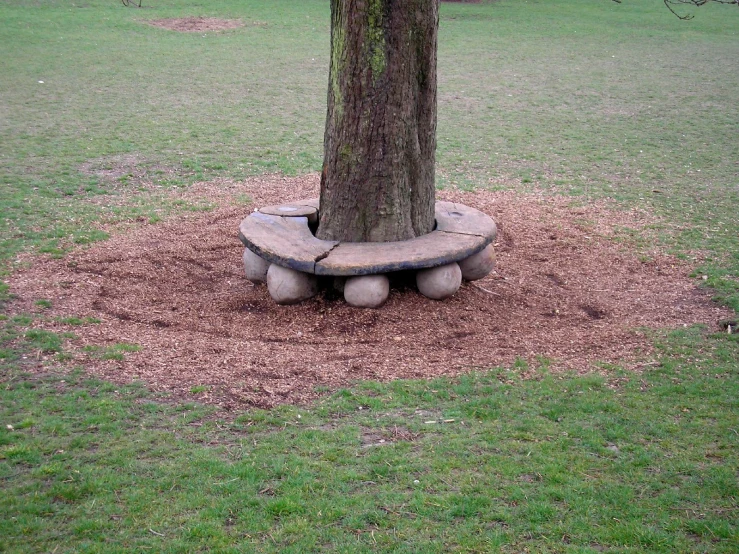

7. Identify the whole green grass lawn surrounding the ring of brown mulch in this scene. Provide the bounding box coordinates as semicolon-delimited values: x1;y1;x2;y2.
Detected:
0;0;739;553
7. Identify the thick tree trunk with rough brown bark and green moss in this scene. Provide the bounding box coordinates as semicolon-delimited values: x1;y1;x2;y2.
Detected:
316;0;439;242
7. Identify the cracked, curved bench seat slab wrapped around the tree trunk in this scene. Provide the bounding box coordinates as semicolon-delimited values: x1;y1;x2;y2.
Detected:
239;199;497;303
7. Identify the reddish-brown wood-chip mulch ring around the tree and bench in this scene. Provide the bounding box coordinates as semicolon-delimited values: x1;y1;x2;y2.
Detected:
10;175;730;408
